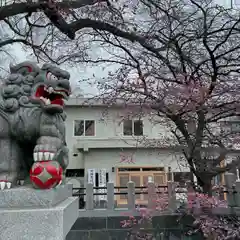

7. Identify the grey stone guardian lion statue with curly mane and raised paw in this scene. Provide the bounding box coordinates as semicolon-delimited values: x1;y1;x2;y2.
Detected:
0;62;71;188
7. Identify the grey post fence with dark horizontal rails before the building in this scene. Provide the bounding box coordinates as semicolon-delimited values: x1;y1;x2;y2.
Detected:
73;173;240;211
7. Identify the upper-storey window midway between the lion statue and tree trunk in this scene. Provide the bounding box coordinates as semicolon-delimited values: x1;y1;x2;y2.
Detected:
123;120;143;136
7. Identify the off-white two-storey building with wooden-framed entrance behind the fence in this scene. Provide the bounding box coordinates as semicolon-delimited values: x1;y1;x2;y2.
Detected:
66;98;239;204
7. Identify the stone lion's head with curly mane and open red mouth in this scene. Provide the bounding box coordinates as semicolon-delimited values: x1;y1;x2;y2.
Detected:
2;62;71;114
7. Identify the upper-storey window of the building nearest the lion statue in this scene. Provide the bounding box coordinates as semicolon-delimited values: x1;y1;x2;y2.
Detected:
74;120;95;136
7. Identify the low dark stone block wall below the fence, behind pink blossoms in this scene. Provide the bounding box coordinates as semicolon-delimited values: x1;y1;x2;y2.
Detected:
66;215;202;240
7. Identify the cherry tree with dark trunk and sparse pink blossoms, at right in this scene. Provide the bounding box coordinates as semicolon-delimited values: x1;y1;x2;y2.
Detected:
68;0;240;192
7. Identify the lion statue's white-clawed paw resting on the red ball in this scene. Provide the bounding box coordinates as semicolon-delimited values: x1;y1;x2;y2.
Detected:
33;144;57;162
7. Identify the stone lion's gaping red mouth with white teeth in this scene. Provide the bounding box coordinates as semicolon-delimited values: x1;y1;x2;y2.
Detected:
35;86;69;106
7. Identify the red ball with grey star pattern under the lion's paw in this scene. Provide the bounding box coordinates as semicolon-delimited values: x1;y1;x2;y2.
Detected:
30;161;63;189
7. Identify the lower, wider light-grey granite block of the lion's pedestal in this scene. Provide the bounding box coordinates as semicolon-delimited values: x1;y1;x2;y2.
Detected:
0;196;79;240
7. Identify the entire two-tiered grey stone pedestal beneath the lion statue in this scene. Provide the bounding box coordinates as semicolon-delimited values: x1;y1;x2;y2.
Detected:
0;185;78;240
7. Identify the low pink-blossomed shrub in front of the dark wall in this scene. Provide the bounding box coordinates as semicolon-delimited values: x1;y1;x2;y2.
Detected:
121;187;240;240
